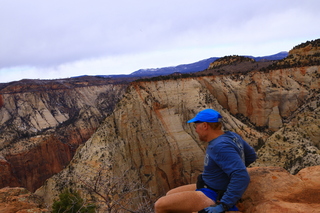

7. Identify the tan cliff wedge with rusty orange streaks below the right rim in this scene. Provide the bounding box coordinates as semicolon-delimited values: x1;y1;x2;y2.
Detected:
199;66;320;131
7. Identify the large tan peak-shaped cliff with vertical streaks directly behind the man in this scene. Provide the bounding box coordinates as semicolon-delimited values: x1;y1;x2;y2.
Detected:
37;78;264;210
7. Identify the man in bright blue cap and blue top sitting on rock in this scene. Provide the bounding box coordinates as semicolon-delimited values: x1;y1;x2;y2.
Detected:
155;109;257;213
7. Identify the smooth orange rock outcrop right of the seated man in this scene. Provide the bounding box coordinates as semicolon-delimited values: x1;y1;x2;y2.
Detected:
239;166;320;213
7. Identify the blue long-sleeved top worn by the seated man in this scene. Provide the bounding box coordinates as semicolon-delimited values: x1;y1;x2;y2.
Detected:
202;131;257;207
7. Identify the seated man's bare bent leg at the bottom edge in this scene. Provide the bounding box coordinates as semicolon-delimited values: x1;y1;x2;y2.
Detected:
155;188;214;213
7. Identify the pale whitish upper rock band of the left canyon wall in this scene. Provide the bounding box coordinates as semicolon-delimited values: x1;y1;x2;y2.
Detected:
0;84;124;148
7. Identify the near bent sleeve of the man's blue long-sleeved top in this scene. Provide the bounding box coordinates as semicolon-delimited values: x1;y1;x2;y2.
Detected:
214;143;253;208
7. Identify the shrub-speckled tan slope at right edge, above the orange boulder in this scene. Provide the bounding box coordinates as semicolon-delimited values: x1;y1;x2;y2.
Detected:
253;94;320;174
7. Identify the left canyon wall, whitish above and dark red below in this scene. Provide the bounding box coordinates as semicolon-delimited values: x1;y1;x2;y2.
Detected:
0;80;127;191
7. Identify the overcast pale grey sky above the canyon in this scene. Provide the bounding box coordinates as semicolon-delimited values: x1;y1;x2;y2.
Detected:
0;0;320;83
